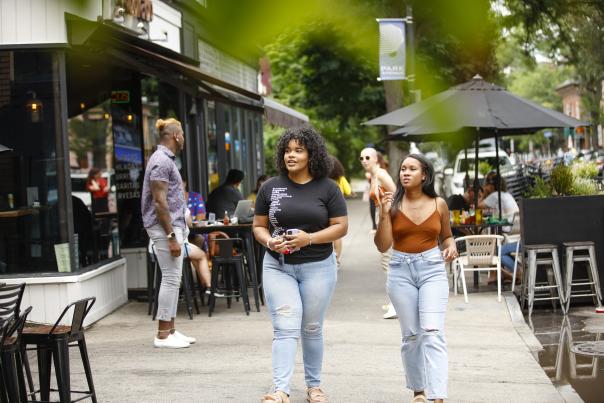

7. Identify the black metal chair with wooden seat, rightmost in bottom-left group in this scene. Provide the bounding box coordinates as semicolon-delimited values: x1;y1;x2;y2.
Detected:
21;297;97;403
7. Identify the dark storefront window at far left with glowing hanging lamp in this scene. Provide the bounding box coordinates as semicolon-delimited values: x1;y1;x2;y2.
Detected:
0;50;71;275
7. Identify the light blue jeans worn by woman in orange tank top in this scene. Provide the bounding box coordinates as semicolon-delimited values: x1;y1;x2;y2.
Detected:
386;247;449;400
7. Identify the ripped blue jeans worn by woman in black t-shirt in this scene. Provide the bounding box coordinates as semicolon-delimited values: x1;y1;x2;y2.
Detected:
263;253;337;394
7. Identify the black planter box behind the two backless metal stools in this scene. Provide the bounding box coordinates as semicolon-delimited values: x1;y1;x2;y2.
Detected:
520;196;604;292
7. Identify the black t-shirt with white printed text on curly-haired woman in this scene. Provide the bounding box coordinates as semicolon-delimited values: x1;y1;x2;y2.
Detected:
254;175;347;264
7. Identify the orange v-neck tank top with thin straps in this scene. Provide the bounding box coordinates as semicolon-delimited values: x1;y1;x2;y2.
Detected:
392;209;441;253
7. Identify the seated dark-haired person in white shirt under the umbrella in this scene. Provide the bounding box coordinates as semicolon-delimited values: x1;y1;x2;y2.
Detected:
478;173;522;283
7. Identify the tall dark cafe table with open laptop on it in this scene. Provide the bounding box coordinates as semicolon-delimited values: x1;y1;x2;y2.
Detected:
190;223;262;312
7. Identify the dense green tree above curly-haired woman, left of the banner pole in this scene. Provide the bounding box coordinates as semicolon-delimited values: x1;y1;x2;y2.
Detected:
265;21;384;177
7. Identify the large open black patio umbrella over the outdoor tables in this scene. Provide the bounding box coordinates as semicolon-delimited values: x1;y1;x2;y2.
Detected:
364;75;589;218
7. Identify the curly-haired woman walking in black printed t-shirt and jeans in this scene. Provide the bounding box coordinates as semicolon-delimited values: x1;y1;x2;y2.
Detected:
254;127;348;403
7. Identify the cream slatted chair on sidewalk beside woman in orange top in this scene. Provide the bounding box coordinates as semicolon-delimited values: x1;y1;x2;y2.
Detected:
453;235;503;303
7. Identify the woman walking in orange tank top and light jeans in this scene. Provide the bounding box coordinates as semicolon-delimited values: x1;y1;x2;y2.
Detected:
374;154;457;403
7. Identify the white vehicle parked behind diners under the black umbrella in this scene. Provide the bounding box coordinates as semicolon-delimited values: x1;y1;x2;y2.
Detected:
445;147;516;197
